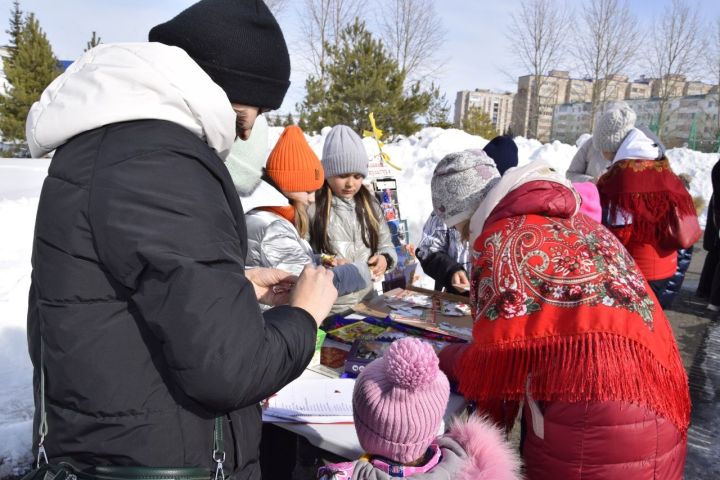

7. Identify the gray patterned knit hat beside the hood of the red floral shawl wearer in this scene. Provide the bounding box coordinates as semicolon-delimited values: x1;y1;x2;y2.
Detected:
430;150;500;227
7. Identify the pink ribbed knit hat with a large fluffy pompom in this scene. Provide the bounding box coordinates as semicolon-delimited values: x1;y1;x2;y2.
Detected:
353;338;450;463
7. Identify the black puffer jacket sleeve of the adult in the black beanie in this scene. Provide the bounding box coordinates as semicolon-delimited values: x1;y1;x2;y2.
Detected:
89;151;316;412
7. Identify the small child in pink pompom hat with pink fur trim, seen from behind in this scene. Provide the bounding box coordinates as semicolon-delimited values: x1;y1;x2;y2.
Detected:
318;338;520;480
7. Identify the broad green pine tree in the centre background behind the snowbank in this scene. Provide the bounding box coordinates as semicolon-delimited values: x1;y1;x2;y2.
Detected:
298;19;432;135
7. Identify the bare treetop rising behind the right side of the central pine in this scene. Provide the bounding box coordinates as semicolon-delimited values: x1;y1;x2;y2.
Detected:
378;0;447;81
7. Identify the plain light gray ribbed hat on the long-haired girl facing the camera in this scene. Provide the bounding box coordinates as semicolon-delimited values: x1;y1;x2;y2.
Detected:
322;125;369;178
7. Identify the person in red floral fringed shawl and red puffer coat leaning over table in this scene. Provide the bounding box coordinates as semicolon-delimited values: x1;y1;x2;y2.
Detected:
432;151;690;479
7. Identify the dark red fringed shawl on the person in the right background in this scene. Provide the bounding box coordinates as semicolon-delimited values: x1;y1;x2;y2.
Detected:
597;158;695;245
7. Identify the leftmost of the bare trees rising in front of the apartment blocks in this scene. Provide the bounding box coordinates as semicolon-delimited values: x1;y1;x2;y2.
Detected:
507;0;570;138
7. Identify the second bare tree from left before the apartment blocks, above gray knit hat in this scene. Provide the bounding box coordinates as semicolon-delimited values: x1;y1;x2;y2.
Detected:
571;0;640;129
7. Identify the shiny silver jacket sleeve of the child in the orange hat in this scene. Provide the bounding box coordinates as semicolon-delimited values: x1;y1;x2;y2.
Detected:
260;219;315;275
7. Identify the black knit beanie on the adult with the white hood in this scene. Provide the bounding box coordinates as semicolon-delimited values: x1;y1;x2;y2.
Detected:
148;0;290;109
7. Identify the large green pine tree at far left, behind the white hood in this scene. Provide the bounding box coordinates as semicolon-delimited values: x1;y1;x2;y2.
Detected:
0;13;60;141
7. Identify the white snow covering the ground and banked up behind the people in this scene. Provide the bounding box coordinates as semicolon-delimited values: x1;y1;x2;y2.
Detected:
0;128;720;472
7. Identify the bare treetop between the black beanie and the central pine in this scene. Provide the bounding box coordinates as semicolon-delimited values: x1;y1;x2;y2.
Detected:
300;0;363;81
